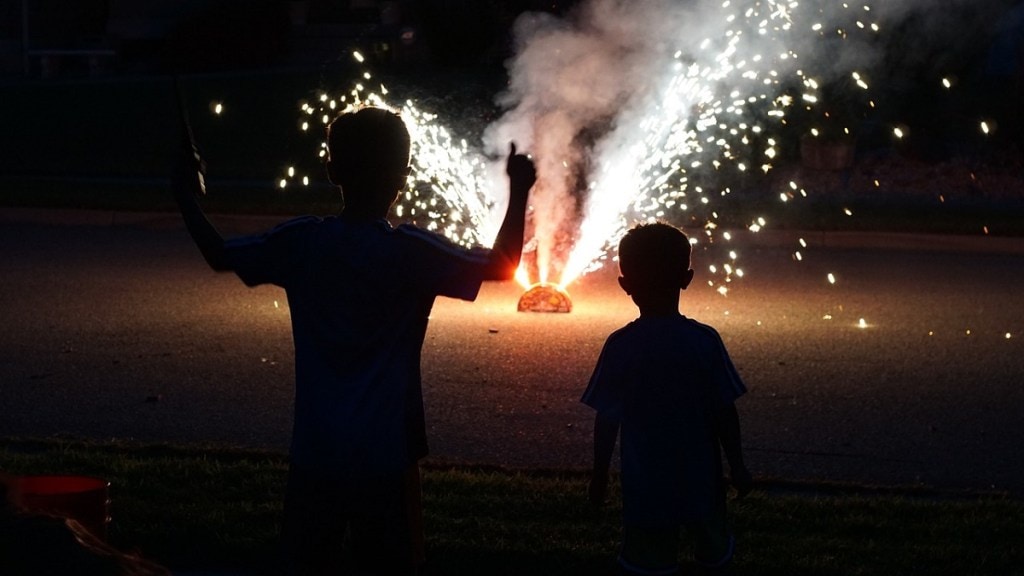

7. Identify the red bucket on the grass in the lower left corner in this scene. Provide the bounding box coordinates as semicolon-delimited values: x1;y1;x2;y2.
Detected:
15;476;111;540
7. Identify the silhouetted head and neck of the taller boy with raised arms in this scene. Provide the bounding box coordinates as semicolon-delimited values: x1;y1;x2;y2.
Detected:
327;108;411;216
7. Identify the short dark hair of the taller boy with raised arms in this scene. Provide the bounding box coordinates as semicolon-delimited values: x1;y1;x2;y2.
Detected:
327;107;412;182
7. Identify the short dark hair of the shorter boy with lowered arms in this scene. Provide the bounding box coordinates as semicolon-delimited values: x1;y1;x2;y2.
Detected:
618;222;690;286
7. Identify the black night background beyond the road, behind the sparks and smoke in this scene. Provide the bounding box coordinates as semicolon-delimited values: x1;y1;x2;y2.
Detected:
0;0;1024;219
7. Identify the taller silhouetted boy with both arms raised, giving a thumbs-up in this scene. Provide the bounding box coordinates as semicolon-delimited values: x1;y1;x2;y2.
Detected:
175;108;536;574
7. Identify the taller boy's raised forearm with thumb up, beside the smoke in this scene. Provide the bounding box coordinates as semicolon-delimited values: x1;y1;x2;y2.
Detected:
483;143;537;280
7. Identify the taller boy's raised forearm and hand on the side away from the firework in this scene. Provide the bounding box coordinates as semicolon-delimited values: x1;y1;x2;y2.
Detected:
171;112;231;272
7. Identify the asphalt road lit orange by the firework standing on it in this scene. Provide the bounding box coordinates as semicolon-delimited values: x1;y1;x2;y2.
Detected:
0;209;1024;494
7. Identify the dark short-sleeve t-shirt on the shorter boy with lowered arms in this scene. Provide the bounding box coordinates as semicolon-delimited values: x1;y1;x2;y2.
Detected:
583;315;746;527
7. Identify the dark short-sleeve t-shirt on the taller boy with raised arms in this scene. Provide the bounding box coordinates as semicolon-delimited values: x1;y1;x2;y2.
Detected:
225;216;487;476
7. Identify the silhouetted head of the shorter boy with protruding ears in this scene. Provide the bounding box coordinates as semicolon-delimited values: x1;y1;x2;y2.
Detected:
618;222;693;305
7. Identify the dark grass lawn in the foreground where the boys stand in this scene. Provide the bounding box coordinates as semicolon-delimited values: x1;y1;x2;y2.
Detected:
0;439;1024;576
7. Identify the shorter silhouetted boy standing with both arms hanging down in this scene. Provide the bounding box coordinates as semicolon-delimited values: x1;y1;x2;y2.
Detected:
583;222;751;575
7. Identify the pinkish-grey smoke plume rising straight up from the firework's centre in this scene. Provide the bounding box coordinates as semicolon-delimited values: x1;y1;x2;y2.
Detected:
485;0;700;281
